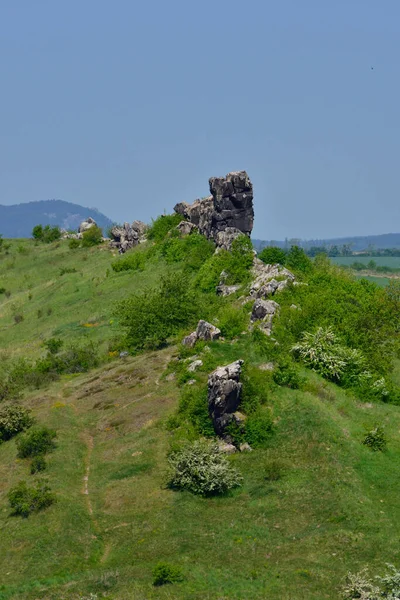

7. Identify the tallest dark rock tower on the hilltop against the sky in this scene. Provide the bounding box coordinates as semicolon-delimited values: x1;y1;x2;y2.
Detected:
174;171;254;250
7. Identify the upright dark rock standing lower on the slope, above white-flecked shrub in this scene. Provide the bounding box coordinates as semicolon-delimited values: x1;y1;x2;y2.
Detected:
208;360;243;435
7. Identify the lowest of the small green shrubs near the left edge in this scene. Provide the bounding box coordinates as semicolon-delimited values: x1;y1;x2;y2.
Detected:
8;481;55;518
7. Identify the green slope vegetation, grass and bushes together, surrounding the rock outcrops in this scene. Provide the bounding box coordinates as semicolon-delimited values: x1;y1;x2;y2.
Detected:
0;218;400;600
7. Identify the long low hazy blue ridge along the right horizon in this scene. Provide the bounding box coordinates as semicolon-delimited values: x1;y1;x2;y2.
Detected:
253;233;400;252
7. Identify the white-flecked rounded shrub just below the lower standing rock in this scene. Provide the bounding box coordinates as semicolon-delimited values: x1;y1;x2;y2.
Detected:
168;440;242;496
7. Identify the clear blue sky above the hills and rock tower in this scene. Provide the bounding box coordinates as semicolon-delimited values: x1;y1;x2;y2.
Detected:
0;0;400;239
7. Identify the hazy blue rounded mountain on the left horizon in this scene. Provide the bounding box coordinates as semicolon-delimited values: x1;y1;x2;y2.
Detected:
0;200;112;238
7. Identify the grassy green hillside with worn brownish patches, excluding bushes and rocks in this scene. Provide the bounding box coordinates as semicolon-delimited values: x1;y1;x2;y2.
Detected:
0;232;400;600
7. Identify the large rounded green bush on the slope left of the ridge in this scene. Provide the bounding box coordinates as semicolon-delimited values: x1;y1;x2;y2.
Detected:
115;273;199;350
